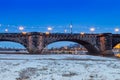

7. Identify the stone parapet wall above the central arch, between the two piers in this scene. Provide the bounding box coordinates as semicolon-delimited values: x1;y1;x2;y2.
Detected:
45;33;97;44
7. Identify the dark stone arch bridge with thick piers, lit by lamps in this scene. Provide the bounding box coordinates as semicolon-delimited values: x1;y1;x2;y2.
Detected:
0;32;120;55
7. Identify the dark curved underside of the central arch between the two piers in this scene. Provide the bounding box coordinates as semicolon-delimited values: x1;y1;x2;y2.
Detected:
44;39;100;55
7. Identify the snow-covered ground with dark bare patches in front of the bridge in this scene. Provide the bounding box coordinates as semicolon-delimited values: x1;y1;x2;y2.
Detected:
0;54;120;80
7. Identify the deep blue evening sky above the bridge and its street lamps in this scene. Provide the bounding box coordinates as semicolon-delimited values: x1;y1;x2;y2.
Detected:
0;0;120;48
